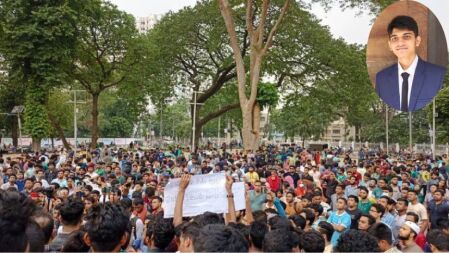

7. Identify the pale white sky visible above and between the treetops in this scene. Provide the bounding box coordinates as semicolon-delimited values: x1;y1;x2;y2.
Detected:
109;0;449;44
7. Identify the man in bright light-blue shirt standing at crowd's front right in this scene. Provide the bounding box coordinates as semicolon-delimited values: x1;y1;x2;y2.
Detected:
327;198;351;247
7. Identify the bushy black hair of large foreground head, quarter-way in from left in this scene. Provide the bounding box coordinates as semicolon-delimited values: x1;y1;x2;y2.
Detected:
84;202;131;252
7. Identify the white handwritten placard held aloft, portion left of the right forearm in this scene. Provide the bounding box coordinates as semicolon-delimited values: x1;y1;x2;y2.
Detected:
164;173;228;218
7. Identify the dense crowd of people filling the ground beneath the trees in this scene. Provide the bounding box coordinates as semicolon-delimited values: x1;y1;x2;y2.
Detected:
0;145;449;252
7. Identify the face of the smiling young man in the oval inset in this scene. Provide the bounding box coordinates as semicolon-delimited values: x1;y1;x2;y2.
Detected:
388;28;421;59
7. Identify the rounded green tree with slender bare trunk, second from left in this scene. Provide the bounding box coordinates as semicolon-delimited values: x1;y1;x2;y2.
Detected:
67;0;145;148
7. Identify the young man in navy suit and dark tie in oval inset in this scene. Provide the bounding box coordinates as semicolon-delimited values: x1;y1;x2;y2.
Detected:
376;16;446;112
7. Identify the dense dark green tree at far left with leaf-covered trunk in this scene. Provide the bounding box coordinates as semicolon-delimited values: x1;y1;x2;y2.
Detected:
0;0;80;150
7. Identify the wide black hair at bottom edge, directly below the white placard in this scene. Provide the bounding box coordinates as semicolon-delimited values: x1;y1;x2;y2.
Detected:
193;224;249;252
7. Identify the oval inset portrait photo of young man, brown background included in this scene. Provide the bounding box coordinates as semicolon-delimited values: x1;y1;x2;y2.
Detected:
366;1;448;112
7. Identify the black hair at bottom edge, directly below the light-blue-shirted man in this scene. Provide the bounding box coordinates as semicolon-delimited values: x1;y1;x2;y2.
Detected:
334;229;380;252
